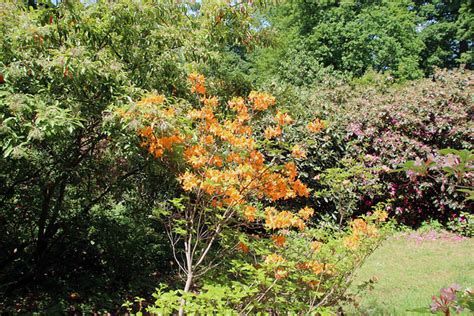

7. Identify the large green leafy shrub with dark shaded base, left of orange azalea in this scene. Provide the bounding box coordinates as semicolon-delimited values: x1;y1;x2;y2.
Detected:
0;0;266;312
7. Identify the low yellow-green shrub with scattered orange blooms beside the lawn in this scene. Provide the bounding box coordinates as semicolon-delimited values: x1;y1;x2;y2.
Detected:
132;212;386;314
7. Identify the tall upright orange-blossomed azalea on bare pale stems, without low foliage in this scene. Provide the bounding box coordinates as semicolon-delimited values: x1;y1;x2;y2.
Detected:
119;73;322;298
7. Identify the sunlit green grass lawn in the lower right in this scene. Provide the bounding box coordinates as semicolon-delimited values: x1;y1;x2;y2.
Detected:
347;231;474;315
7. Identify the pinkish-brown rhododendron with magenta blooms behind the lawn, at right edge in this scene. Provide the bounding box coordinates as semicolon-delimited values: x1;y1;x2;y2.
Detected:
338;71;474;225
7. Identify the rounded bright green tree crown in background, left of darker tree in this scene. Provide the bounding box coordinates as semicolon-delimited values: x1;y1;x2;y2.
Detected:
254;1;423;84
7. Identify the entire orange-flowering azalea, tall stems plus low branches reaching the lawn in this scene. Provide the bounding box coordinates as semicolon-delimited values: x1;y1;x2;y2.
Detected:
118;73;388;314
